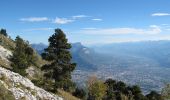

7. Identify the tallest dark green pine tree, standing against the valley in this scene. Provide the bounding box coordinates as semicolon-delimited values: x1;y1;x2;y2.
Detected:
42;29;76;91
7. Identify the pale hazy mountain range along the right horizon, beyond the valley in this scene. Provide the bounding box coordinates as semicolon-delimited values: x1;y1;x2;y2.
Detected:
92;41;170;68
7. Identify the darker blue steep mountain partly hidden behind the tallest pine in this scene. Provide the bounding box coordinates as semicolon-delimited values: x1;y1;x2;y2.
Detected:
31;43;101;70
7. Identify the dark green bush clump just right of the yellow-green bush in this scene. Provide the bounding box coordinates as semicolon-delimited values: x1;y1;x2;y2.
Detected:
105;79;146;100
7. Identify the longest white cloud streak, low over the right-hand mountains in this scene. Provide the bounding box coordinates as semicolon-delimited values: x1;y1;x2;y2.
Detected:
80;25;161;35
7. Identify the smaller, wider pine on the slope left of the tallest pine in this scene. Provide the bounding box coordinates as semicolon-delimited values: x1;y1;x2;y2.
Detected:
11;36;33;76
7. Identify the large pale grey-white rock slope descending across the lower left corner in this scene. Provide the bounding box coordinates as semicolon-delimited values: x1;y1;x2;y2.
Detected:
0;67;63;100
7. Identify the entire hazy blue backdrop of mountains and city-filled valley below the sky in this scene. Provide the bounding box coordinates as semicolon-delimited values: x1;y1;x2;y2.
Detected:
32;41;170;93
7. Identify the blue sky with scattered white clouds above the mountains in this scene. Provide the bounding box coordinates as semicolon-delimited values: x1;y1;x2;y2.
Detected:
0;0;170;45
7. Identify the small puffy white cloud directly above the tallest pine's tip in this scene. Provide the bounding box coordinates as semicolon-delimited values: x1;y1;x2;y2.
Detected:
53;17;75;24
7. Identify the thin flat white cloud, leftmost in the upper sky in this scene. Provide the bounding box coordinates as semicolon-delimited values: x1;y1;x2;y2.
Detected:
20;17;49;22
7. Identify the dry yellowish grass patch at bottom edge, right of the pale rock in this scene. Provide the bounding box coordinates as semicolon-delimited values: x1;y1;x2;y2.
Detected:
57;90;80;100
